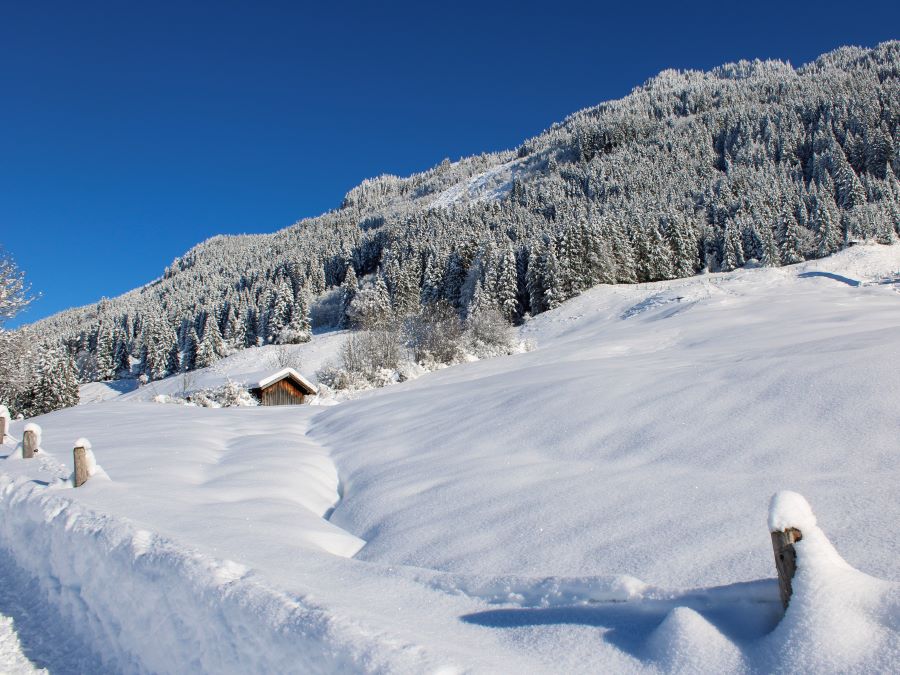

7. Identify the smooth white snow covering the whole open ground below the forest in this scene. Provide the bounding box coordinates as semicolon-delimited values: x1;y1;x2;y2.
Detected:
0;246;900;673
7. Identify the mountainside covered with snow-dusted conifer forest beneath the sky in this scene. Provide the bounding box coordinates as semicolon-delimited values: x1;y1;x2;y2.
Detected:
0;41;900;412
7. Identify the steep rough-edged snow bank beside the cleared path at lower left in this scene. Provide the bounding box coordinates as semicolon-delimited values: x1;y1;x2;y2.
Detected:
0;476;394;673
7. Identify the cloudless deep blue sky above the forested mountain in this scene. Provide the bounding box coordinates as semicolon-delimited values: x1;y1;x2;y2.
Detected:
0;0;900;328
